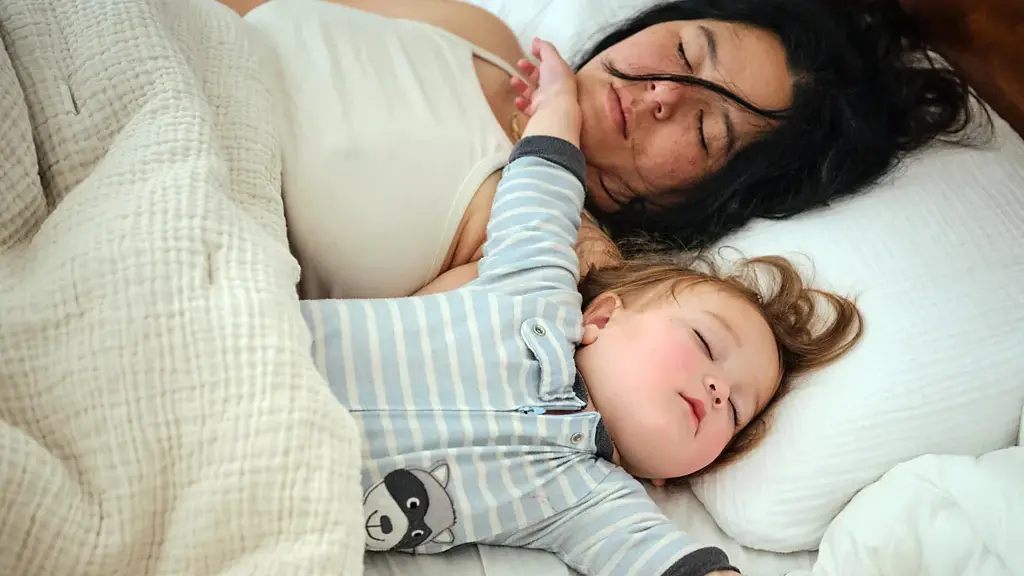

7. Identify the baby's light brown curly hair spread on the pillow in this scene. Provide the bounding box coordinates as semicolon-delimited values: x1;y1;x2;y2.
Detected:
580;253;863;480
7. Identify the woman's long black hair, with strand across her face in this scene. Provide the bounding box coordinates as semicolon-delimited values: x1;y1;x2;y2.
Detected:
575;0;973;249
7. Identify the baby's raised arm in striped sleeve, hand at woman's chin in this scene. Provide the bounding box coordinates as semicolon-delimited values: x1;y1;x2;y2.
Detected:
474;40;587;293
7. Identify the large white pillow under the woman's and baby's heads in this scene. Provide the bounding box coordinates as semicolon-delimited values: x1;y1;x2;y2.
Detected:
473;0;1024;551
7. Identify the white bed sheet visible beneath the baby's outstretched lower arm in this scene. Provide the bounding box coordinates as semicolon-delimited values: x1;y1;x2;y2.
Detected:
366;479;817;576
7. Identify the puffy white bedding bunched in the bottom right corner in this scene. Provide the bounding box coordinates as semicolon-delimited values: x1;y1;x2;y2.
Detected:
791;447;1024;576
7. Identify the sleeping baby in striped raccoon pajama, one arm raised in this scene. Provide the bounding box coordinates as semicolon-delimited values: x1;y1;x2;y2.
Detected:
302;41;861;576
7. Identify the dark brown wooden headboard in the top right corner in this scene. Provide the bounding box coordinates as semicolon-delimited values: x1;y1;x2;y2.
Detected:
899;0;1024;135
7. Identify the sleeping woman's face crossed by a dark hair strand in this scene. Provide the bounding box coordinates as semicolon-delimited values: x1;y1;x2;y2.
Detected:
578;20;793;212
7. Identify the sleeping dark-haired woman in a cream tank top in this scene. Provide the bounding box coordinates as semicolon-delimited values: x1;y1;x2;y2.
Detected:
221;0;971;298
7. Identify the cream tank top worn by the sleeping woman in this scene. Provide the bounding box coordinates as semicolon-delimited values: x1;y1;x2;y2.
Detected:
245;0;518;298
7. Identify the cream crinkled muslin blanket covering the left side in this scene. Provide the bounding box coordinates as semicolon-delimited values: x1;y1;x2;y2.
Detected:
0;0;362;576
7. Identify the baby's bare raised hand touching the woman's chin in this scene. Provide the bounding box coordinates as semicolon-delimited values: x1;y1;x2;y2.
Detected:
510;39;583;147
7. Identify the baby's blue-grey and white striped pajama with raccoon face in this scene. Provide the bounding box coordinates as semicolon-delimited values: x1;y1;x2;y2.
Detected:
302;145;727;576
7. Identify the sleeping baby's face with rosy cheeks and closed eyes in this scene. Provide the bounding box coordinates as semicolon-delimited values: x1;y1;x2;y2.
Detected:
577;283;781;480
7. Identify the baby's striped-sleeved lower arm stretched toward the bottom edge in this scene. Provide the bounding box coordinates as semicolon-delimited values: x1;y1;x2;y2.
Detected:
494;470;737;576
